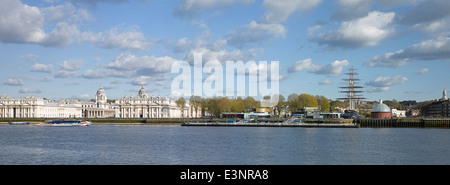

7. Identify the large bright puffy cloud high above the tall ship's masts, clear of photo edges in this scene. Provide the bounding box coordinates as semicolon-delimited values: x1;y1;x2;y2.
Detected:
312;11;395;49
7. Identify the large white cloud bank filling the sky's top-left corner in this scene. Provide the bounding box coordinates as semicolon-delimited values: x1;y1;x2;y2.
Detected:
0;0;152;51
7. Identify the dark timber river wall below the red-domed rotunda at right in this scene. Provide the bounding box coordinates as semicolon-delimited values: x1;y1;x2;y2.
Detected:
354;118;450;128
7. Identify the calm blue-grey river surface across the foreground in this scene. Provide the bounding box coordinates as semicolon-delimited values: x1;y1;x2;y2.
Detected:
0;125;450;165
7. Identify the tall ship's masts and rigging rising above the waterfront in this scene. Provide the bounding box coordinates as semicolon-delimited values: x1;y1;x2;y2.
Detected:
338;66;366;111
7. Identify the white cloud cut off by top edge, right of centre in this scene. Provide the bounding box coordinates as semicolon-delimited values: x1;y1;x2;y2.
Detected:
262;0;321;23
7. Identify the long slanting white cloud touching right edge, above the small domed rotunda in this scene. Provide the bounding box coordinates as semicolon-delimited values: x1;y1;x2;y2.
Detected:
367;37;450;67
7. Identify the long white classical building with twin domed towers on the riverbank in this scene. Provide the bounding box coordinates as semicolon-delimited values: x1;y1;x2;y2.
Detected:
0;85;201;118
